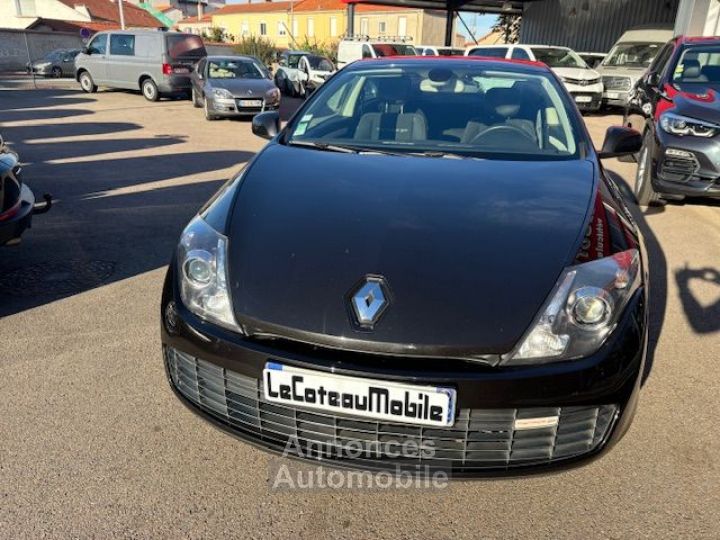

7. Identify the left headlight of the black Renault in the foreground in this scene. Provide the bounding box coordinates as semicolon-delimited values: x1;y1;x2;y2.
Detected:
177;216;238;330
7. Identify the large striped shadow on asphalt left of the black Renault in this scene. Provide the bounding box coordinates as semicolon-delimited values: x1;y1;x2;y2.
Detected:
0;91;253;317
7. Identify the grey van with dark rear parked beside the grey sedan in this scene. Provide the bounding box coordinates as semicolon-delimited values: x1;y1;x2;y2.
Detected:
75;29;207;101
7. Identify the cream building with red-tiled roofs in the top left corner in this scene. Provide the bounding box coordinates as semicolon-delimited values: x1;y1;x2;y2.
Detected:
0;0;163;32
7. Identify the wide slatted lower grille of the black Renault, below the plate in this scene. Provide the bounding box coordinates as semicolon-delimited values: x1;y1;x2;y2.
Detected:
165;347;617;472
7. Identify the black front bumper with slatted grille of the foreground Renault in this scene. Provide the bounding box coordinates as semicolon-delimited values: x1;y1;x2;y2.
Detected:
161;271;647;477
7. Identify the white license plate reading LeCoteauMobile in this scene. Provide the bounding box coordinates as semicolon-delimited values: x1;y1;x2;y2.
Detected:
263;362;455;426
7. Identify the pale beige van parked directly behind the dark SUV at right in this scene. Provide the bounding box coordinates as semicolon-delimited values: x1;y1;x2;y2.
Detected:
597;26;673;107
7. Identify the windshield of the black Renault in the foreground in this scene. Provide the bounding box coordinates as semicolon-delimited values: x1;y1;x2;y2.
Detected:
286;61;579;159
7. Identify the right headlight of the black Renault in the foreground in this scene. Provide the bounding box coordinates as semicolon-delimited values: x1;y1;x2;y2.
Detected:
502;249;640;365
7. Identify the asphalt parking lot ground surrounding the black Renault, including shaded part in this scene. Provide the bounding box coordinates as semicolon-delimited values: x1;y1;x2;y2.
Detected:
0;87;720;538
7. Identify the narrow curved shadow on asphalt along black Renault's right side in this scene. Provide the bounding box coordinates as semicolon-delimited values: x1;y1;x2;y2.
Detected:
605;169;668;384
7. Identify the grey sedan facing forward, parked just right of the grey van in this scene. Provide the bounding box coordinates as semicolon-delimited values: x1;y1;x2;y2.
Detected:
191;56;280;120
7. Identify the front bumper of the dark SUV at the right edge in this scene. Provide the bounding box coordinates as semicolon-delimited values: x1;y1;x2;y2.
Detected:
652;129;720;197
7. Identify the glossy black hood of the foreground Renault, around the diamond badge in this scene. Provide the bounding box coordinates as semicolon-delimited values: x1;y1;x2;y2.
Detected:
227;144;594;356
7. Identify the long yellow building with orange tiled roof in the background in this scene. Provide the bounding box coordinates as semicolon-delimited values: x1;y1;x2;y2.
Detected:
202;0;445;48
